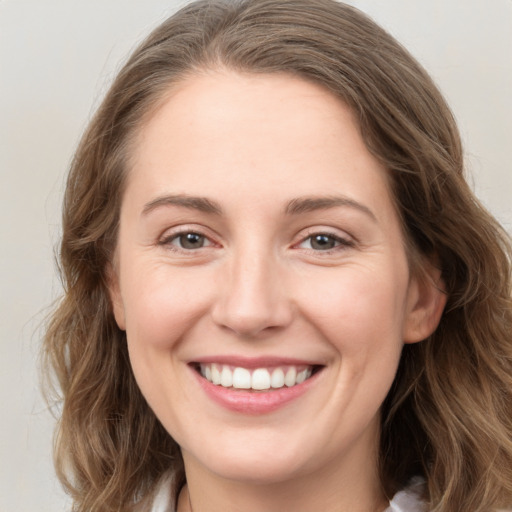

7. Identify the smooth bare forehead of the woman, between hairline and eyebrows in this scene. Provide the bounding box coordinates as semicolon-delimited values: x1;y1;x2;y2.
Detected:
128;70;396;223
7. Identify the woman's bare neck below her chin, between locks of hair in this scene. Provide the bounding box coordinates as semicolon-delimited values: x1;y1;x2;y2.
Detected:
178;432;388;512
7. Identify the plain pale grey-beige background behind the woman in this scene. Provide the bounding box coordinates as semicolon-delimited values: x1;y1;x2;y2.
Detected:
0;0;512;512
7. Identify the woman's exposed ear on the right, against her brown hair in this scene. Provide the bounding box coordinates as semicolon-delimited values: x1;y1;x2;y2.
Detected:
402;263;447;343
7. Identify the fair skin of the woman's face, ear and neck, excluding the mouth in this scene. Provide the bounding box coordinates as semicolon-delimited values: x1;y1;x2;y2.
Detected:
111;70;444;512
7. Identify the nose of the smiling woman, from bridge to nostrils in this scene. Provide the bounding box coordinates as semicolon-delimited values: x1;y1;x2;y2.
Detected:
212;252;293;338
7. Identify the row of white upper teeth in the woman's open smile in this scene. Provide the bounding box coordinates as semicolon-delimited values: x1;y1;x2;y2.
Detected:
199;364;312;390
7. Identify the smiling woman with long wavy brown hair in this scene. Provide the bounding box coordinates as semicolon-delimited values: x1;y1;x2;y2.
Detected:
45;0;512;512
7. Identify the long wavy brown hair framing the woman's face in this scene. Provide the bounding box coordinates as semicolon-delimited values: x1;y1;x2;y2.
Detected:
44;0;512;512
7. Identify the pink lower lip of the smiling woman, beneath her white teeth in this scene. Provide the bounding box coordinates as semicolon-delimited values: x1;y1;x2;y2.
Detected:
191;369;321;415
